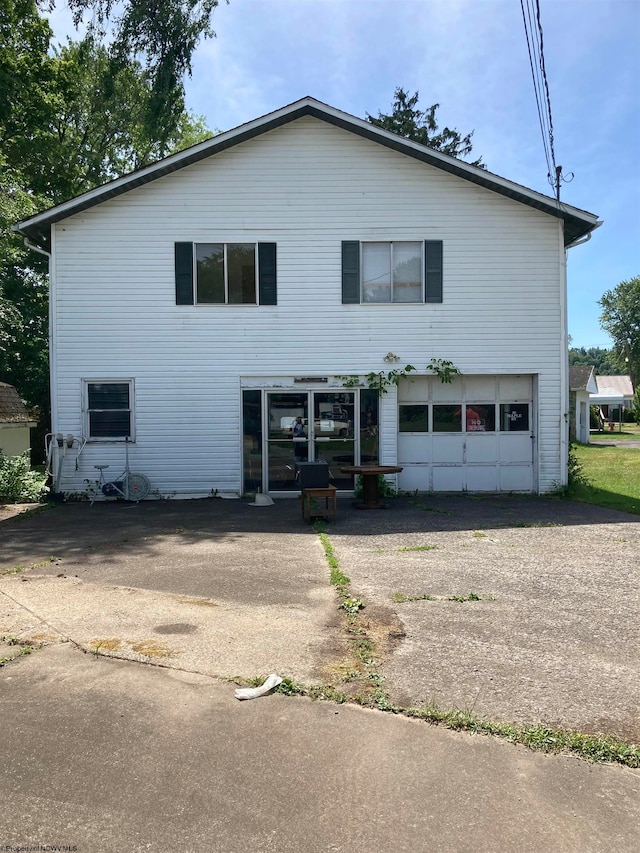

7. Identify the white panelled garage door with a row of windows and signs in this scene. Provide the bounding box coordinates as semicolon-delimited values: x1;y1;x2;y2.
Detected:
398;375;535;492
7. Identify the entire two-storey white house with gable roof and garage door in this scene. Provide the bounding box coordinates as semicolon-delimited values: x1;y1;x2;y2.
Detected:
16;98;599;497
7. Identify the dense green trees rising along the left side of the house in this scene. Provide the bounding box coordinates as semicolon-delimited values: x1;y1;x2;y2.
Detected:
0;0;215;456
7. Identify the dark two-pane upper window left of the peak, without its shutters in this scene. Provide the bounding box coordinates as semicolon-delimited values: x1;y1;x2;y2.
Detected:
194;243;258;305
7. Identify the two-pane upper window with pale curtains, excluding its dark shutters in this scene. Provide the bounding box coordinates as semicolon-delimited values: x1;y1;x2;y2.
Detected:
361;240;424;302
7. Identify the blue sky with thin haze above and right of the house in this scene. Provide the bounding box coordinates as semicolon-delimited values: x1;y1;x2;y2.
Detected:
47;0;640;347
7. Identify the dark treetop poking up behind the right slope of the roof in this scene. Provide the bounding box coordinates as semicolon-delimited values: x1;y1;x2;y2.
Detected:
367;87;485;168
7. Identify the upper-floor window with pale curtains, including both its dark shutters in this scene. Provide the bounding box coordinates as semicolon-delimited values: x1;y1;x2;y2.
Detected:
342;240;442;304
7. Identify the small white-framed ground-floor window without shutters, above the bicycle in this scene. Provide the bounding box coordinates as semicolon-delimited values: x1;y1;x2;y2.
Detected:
82;379;135;441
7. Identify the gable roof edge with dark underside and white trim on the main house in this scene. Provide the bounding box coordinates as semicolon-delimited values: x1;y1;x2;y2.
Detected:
13;97;602;251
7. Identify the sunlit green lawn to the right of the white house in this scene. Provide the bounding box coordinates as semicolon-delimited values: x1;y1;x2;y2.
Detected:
568;436;640;515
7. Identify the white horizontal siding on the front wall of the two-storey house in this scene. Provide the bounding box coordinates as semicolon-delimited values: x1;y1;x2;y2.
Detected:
52;117;565;496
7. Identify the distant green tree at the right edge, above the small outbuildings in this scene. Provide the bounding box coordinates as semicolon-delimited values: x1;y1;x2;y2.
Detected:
599;276;640;387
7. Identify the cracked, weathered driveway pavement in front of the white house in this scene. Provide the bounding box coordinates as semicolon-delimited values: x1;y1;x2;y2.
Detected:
0;496;640;853
